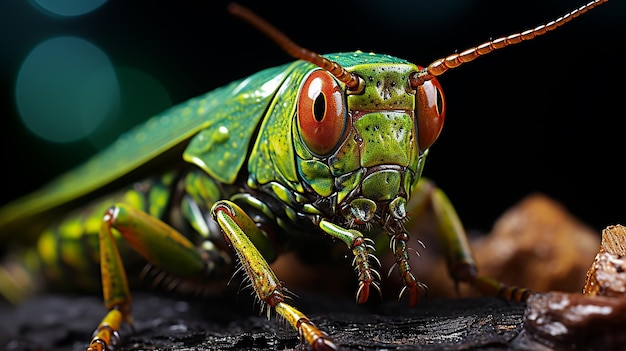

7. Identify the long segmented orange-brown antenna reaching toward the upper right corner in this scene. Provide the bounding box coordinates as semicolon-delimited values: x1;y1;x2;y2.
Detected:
416;0;608;82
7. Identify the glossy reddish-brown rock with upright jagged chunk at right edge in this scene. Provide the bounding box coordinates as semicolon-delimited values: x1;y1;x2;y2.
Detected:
524;225;626;351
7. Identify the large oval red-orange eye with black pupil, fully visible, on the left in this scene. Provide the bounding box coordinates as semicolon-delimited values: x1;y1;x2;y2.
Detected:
298;70;346;156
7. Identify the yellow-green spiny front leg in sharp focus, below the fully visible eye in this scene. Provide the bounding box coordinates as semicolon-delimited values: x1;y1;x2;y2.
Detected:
211;201;337;351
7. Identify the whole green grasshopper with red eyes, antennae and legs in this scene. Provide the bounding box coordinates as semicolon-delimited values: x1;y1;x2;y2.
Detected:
0;0;606;350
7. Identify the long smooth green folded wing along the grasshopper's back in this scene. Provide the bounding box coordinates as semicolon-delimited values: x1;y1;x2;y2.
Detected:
0;64;292;242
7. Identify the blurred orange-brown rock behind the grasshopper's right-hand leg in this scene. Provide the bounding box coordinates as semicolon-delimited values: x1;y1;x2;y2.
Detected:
472;194;600;292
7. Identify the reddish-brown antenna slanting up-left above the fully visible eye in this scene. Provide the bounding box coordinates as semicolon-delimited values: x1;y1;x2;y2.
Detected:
228;3;365;94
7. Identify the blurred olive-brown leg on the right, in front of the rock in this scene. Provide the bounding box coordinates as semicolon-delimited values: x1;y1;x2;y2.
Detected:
413;179;531;301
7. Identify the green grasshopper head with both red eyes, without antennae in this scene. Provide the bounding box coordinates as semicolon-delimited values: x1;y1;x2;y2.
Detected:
295;52;445;225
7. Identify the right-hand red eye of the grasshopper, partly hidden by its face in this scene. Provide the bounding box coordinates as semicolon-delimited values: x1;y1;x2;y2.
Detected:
415;78;446;150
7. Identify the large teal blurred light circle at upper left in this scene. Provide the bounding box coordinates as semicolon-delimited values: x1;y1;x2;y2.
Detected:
15;37;120;142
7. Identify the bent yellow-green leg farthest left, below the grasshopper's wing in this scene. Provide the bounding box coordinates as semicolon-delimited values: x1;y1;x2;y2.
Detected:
87;203;205;351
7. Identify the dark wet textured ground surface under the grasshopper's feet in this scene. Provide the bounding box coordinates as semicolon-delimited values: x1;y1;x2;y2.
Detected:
0;294;541;351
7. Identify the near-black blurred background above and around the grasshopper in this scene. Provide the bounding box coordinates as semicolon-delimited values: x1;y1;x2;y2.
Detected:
0;0;626;236
